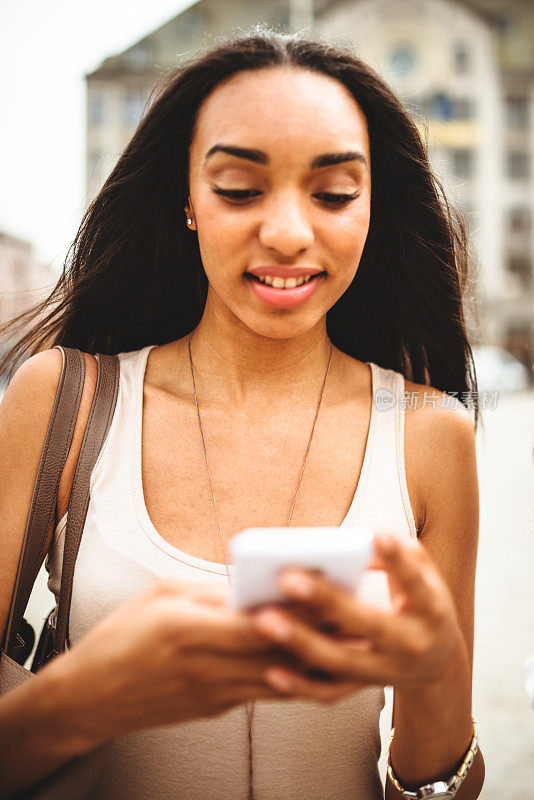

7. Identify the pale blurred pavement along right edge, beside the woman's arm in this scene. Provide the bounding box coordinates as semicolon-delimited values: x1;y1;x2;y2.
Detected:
473;391;534;800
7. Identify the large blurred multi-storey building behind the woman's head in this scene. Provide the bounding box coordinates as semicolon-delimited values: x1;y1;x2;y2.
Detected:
87;0;534;364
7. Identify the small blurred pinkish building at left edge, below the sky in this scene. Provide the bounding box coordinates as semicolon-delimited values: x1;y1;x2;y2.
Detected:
0;232;57;325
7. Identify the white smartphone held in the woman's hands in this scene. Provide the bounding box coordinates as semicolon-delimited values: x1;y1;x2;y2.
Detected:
230;526;372;609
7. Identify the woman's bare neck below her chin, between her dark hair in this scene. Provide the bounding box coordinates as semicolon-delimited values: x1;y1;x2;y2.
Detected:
187;290;334;409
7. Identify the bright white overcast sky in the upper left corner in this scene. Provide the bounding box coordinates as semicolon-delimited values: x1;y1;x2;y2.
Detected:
0;0;194;269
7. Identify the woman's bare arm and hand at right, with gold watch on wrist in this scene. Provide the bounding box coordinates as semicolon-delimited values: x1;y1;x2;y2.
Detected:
251;407;484;800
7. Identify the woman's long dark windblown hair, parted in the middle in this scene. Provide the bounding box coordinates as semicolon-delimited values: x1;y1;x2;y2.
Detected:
0;27;478;417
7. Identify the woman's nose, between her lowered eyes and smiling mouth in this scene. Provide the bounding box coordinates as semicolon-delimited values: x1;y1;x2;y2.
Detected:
260;194;314;258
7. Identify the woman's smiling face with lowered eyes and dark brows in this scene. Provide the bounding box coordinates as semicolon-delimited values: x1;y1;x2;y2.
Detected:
186;67;371;338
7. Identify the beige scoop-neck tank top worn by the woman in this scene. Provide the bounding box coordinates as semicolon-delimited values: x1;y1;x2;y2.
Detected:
45;345;417;800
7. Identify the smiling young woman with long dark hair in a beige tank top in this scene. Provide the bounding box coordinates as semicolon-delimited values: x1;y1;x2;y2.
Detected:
0;30;484;800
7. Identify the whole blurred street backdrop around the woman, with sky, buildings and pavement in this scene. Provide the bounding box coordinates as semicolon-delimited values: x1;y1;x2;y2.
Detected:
0;0;534;800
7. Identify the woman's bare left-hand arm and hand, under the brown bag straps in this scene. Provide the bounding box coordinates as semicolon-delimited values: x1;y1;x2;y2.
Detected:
0;350;298;800
